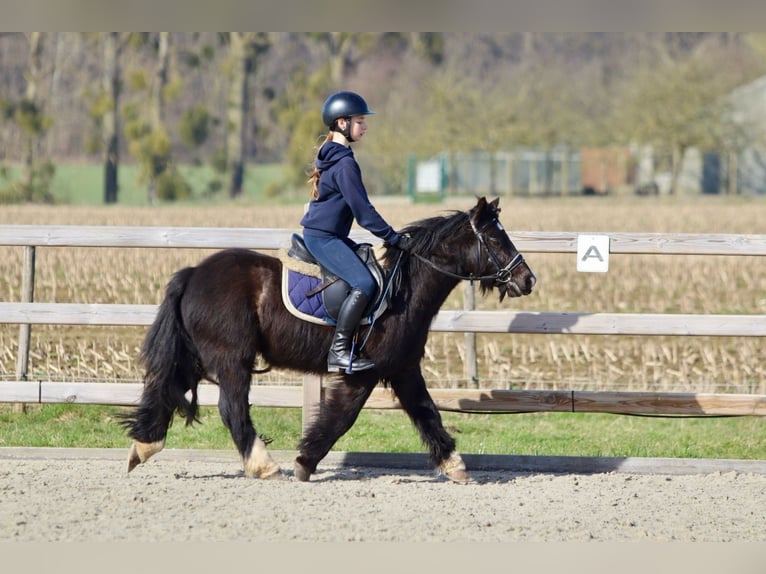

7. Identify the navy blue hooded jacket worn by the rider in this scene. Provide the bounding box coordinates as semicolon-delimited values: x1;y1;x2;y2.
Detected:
301;142;399;245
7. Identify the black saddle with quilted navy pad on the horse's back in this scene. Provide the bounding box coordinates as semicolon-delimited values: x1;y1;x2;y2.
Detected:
282;233;390;325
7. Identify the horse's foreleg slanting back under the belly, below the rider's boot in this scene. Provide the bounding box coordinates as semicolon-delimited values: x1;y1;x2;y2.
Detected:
295;380;377;481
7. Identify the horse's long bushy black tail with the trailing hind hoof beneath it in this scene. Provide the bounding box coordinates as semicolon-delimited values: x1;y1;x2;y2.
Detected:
122;267;202;470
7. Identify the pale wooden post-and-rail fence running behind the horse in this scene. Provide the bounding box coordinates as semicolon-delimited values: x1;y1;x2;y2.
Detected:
0;225;766;432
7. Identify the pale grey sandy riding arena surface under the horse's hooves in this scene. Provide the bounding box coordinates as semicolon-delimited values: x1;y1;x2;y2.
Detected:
0;449;766;542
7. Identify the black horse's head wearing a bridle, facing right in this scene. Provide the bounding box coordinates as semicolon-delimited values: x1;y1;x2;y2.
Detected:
468;197;537;301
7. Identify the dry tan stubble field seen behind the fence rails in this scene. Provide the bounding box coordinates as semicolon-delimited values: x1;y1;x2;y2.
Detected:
0;197;766;393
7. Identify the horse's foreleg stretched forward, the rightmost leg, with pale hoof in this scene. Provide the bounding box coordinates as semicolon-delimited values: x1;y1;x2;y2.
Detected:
390;368;471;483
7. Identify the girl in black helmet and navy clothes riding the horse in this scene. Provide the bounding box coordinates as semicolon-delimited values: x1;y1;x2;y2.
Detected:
301;91;409;372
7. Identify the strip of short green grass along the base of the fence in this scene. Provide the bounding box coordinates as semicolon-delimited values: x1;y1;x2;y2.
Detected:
0;404;766;460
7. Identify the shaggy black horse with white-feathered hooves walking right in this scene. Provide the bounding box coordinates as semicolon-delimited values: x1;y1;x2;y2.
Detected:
123;198;536;482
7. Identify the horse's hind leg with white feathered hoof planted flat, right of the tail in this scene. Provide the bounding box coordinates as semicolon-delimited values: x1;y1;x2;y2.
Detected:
218;371;284;479
